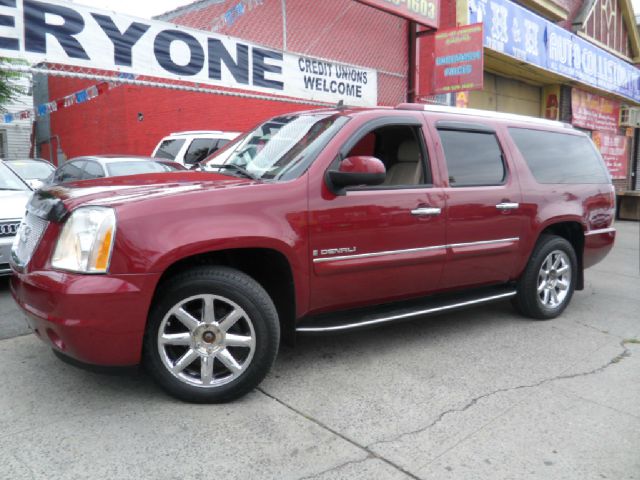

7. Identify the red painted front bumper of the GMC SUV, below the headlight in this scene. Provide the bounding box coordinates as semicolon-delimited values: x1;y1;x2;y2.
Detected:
11;270;160;366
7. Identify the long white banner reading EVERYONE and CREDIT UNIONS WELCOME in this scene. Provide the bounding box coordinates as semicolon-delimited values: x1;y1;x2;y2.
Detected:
0;0;378;106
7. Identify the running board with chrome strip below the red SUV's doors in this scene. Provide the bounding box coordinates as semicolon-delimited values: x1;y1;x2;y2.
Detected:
296;286;516;334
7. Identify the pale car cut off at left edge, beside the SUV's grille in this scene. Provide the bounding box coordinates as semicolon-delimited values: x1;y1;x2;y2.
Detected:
0;162;32;276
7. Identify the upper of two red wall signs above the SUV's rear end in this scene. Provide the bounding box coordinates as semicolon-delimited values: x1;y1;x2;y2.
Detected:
571;88;620;132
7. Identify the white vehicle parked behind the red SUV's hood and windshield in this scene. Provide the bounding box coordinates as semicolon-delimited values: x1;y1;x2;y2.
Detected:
152;130;240;168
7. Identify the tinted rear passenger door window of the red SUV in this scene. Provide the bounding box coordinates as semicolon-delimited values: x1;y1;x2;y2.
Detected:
439;130;505;187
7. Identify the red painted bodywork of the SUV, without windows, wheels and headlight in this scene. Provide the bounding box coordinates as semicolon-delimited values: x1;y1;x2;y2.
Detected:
12;109;615;365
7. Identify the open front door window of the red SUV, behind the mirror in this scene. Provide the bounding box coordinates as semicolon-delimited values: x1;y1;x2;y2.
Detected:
347;125;431;189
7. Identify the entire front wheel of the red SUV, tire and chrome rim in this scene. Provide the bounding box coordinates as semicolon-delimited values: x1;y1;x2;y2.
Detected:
144;267;280;403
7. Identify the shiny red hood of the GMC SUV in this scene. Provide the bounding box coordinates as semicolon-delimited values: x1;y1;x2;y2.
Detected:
32;171;262;218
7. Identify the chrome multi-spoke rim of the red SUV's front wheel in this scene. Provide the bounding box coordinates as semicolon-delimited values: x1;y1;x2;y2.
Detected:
157;294;256;388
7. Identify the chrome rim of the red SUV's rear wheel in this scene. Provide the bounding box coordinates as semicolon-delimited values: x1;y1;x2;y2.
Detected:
537;250;572;309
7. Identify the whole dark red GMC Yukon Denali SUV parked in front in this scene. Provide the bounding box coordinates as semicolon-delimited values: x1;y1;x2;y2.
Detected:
11;104;615;402
